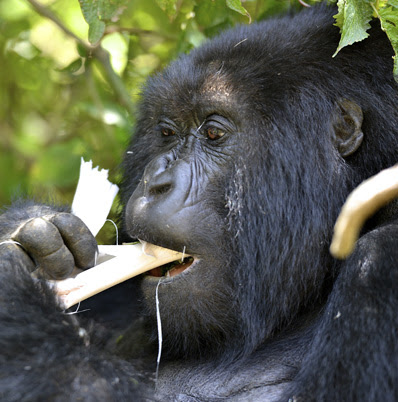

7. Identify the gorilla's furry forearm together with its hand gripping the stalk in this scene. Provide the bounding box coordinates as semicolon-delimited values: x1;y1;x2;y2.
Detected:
0;202;148;401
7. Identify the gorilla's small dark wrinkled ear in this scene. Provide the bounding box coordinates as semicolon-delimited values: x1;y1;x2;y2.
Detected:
332;99;363;158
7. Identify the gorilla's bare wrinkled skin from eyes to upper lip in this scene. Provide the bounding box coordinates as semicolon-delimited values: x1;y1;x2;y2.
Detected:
126;116;233;256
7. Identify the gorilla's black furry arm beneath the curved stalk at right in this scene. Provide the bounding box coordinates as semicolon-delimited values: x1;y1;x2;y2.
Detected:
289;220;398;401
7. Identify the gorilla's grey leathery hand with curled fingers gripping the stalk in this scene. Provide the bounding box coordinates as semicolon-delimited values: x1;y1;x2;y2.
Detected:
0;212;97;279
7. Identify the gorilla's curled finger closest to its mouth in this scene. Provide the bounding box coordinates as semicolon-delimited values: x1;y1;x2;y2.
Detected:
49;213;98;269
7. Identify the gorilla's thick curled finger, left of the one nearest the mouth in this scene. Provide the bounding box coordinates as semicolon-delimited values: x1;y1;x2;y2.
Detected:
12;218;75;279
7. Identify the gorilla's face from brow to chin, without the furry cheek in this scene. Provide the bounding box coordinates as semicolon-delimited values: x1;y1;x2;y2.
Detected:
125;74;244;356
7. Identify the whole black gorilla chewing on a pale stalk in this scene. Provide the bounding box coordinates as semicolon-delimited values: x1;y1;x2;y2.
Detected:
0;6;398;402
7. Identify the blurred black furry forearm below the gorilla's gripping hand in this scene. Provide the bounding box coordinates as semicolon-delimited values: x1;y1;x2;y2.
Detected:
0;258;148;402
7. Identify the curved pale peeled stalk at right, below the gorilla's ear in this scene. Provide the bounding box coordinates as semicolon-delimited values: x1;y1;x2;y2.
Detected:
330;165;398;259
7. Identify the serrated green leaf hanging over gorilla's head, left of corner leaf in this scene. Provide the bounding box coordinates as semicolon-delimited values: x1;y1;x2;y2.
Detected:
333;0;373;57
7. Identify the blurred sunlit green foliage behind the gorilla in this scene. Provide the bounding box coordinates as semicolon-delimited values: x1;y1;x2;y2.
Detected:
0;0;320;242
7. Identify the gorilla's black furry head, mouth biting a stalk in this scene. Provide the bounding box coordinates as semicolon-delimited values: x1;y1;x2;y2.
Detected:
122;8;396;355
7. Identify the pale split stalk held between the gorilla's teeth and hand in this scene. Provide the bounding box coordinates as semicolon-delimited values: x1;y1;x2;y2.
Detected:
52;243;188;308
